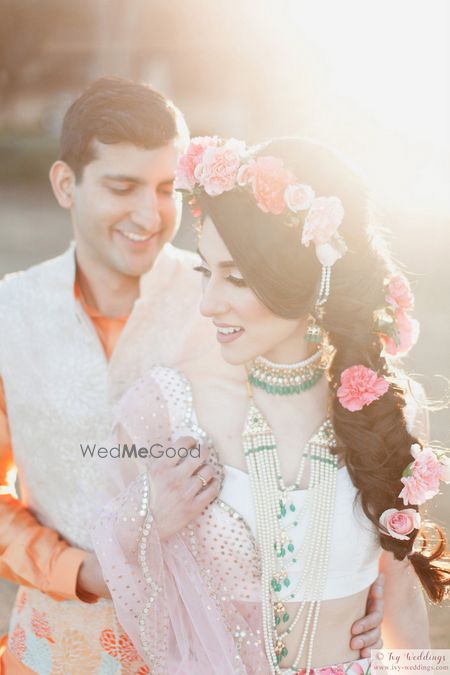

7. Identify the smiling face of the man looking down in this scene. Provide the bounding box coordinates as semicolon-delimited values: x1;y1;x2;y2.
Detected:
72;141;181;277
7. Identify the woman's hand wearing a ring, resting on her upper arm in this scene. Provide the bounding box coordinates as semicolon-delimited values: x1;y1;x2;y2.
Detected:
149;436;220;539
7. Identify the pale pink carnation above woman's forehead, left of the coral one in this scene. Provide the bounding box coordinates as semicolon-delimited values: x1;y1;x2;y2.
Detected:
194;138;245;197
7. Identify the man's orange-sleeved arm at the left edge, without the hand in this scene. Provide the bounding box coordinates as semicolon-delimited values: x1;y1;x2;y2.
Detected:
0;378;97;602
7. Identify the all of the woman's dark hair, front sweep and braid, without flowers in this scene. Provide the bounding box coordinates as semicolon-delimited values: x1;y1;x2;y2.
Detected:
198;138;450;602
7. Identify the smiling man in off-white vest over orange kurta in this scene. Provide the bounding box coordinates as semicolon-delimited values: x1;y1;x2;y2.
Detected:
0;78;382;675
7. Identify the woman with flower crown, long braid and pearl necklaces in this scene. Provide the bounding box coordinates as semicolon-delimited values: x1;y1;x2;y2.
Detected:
89;138;449;675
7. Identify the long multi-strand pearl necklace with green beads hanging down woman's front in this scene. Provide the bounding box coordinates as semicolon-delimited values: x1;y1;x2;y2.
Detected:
242;392;337;675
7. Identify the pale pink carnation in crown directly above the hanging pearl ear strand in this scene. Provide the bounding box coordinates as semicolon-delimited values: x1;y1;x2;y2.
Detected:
302;197;344;246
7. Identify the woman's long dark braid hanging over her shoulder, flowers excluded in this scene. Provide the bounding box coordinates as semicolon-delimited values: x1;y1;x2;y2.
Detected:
323;242;450;602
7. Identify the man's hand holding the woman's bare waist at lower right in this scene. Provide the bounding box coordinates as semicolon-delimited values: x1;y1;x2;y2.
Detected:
350;574;384;659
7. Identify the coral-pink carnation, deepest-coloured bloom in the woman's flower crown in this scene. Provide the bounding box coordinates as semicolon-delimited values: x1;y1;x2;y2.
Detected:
246;156;295;214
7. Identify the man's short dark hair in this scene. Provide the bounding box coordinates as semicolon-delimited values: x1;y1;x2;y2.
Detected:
60;77;184;181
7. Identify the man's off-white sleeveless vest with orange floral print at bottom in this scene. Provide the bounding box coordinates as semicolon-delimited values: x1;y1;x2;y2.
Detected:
0;244;215;675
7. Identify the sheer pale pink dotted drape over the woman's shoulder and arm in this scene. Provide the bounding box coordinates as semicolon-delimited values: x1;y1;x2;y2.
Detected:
91;367;269;675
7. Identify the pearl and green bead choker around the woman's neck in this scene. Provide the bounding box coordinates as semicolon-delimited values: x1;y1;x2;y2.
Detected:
247;349;328;396
